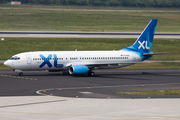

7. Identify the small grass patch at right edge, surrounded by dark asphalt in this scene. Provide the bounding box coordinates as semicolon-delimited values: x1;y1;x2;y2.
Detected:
116;89;180;95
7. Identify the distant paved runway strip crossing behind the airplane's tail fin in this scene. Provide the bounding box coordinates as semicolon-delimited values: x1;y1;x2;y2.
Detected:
0;31;180;39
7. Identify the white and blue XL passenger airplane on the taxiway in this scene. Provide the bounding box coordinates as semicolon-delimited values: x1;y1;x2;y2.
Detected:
4;19;171;76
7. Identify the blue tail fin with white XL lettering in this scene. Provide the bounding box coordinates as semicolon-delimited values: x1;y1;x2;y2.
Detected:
123;19;158;54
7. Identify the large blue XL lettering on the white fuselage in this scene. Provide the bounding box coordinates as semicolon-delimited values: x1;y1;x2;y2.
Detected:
39;54;63;68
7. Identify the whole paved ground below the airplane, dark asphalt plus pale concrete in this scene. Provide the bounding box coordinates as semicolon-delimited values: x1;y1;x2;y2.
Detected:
0;69;180;120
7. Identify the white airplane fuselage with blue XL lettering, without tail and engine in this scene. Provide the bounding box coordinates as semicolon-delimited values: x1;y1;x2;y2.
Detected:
5;51;142;71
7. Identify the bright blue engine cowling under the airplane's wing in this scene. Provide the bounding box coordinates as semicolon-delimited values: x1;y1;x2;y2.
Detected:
69;65;89;75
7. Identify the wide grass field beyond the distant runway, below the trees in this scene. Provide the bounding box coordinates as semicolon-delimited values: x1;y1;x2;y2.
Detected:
0;6;180;32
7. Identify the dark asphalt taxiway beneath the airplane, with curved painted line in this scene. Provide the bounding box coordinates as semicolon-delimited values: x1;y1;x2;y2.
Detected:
0;69;180;99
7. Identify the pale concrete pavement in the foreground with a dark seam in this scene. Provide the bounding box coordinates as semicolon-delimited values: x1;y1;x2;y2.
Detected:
0;96;180;120
